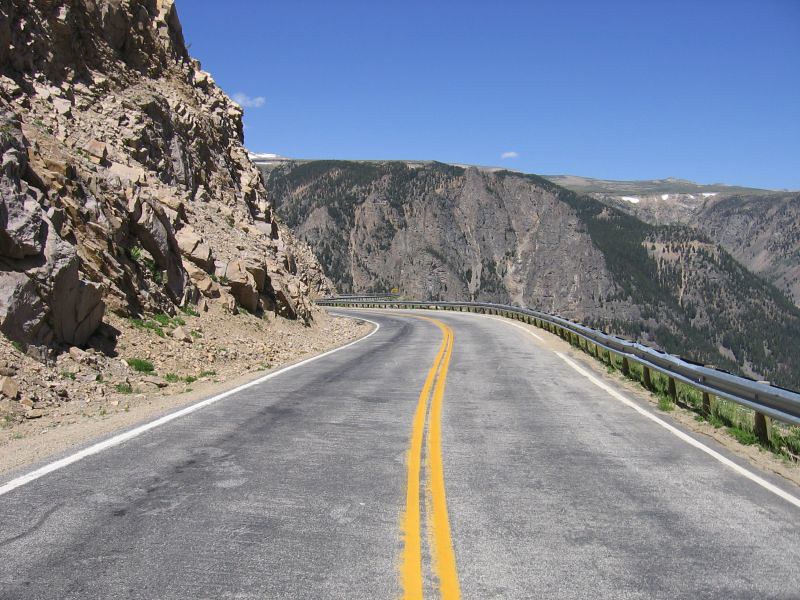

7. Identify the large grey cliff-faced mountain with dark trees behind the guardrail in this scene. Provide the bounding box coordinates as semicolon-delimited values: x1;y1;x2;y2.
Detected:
261;161;800;387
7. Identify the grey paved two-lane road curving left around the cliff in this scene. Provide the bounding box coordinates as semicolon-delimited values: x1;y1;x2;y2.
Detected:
0;311;800;600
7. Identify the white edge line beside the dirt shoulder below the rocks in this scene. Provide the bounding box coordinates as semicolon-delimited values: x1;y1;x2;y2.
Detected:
0;317;381;496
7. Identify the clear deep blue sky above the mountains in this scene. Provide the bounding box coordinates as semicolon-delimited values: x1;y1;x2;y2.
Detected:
177;0;800;189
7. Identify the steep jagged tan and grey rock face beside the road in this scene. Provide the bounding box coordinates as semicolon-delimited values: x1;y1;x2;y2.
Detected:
0;0;331;344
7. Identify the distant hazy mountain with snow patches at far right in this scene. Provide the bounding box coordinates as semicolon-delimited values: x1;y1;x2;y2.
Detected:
547;175;800;306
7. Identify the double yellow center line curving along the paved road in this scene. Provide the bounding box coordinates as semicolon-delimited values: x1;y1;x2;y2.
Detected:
400;317;461;600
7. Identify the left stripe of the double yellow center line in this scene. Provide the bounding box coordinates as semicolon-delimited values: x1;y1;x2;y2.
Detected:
400;322;449;600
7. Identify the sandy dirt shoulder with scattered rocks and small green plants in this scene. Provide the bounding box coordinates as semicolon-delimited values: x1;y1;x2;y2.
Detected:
0;306;373;474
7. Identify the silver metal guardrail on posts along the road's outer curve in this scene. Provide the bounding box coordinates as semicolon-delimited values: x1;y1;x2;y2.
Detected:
317;295;800;428
